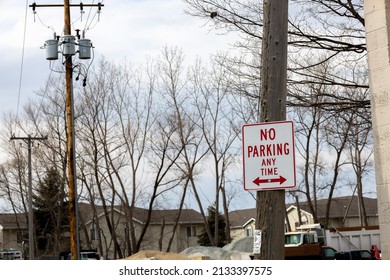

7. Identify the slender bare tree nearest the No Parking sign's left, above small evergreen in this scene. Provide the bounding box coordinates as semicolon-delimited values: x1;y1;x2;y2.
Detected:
190;55;240;244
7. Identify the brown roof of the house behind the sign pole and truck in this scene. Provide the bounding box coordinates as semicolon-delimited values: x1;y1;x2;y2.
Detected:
229;196;378;228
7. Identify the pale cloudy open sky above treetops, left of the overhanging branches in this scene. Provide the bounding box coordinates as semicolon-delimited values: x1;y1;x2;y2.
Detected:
0;0;238;115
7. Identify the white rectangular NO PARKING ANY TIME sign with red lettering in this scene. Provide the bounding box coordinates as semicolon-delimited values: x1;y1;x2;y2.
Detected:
242;121;296;190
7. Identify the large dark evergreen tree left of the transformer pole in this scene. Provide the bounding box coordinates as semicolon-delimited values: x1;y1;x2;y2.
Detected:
33;168;69;254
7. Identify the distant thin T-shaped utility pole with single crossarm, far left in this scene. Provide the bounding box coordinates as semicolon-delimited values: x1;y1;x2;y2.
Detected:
11;135;47;260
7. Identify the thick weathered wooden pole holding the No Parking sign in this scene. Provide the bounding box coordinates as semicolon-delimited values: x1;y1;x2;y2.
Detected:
254;0;288;260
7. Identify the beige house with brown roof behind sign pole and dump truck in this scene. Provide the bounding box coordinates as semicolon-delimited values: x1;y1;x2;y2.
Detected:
229;196;379;239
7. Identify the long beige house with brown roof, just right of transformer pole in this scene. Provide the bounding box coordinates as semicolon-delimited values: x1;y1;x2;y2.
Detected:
76;202;204;258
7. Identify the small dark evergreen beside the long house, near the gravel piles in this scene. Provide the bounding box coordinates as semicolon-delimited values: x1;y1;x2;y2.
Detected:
198;205;227;247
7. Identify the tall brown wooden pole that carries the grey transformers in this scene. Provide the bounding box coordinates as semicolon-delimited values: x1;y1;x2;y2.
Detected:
64;0;79;260
